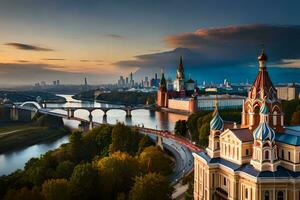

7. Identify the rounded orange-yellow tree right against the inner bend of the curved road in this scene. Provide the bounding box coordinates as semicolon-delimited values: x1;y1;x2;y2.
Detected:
139;146;172;175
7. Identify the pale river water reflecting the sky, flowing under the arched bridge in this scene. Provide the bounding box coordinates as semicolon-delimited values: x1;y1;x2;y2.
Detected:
0;95;187;176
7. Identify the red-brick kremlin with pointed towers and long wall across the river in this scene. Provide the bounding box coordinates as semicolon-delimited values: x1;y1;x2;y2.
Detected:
156;57;246;113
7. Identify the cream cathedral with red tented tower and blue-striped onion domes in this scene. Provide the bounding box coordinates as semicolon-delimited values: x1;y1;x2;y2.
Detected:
193;50;300;200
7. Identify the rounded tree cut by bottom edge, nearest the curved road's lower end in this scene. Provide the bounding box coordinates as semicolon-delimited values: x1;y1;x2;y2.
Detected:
129;173;173;200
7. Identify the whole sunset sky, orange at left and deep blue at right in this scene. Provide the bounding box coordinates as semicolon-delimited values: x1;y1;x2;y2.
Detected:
0;0;300;86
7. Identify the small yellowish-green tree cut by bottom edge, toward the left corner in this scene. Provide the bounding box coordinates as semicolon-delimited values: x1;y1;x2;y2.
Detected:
42;179;71;200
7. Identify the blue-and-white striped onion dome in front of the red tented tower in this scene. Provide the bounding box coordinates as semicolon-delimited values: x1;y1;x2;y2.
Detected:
253;122;275;142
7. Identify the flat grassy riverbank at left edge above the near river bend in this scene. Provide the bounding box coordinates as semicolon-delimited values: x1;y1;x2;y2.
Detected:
0;124;69;154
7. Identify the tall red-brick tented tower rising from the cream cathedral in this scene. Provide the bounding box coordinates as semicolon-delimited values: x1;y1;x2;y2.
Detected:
241;49;284;132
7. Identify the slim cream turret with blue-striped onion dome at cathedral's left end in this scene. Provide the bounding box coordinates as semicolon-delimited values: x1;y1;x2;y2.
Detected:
206;99;224;158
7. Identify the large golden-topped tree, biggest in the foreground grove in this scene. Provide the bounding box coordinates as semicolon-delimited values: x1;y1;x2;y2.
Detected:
96;152;139;199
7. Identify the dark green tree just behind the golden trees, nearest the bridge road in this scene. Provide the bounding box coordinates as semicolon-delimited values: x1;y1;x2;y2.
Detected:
109;123;139;155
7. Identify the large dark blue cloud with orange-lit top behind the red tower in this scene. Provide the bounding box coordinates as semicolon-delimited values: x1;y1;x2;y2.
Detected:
115;24;300;83
